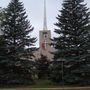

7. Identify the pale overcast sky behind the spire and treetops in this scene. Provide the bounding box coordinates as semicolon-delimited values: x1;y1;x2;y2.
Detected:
0;0;90;46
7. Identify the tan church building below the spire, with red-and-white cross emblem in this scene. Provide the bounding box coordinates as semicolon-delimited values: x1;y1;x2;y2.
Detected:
34;30;54;61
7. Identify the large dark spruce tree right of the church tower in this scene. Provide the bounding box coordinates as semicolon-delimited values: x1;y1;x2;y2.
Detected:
50;0;90;83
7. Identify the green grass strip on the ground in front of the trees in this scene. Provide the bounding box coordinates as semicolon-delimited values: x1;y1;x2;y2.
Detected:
0;80;90;90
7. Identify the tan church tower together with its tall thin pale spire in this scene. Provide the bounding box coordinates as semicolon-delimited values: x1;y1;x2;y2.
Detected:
39;0;51;59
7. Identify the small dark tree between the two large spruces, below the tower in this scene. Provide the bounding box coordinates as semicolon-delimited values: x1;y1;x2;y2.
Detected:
36;55;49;79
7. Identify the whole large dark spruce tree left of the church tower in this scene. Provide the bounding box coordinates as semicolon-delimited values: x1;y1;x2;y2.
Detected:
0;0;36;85
